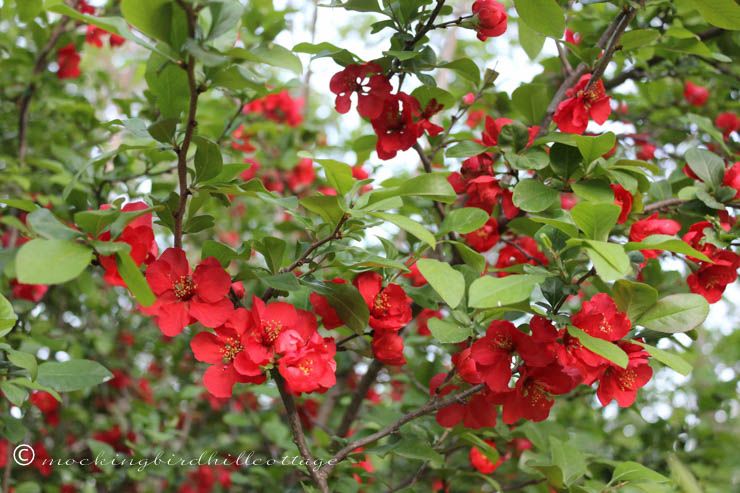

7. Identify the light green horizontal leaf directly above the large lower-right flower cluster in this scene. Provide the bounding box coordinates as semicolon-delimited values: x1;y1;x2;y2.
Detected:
468;274;546;308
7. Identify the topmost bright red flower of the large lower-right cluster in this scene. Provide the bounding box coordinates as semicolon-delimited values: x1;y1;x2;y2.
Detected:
571;293;632;341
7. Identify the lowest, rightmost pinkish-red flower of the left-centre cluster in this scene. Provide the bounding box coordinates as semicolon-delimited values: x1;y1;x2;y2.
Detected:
278;332;337;393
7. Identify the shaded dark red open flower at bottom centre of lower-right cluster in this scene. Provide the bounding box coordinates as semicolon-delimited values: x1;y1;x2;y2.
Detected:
493;364;578;425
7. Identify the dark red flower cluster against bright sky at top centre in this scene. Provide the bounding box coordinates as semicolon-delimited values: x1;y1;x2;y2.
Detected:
329;62;443;159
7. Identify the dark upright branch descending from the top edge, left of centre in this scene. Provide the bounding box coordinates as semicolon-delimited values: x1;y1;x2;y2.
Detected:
174;0;200;248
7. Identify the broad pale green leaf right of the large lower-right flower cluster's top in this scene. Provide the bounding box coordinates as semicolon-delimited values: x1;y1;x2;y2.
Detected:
633;293;709;334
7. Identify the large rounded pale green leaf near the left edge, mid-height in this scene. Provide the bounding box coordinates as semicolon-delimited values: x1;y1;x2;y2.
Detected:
15;239;93;284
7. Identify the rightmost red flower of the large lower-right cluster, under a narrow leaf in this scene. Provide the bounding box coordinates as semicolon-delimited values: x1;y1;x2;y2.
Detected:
596;342;653;407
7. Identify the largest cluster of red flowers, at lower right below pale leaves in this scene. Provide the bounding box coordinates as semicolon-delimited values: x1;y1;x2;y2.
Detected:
430;293;652;429
